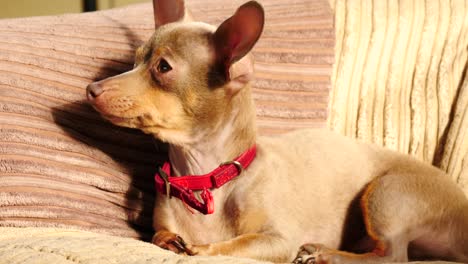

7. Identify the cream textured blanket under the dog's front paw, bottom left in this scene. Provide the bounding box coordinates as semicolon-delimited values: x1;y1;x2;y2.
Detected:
0;228;264;264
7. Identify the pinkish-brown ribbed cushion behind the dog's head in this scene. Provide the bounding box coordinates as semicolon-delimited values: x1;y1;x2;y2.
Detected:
0;0;334;238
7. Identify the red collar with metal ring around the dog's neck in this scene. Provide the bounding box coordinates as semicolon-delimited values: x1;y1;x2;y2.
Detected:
154;145;257;214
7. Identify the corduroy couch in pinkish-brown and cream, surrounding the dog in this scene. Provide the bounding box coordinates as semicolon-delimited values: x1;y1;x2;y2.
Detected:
0;0;468;263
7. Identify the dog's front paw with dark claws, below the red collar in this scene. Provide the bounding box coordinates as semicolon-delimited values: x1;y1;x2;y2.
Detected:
151;230;196;256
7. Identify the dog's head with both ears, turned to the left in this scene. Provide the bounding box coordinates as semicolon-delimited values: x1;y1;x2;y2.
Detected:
87;0;264;144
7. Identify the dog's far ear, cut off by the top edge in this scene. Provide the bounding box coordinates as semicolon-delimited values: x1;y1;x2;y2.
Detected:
153;0;185;28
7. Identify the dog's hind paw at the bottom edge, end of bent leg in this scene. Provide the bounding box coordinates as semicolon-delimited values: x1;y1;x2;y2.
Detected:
293;244;340;264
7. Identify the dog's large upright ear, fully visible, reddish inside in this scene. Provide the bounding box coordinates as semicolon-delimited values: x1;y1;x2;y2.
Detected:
214;1;265;93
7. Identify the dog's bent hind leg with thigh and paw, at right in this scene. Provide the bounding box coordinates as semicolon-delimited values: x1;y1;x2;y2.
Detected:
295;170;468;263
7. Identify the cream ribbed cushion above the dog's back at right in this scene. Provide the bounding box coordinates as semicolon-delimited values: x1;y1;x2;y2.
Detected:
329;0;468;194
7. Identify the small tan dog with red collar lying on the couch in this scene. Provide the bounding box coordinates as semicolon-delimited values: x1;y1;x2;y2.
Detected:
87;0;468;263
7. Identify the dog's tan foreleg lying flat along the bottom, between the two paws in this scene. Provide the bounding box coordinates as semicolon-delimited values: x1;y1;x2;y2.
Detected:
187;233;294;262
